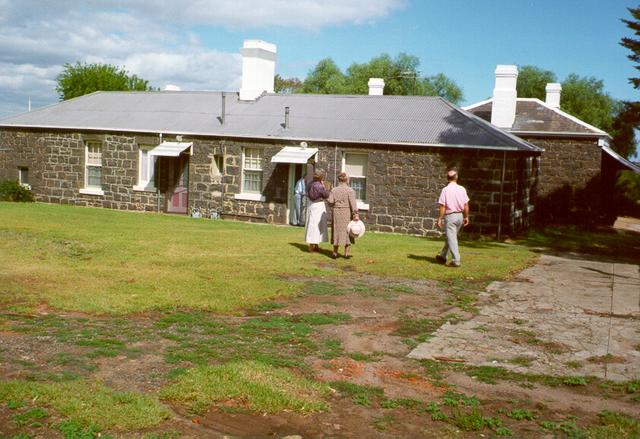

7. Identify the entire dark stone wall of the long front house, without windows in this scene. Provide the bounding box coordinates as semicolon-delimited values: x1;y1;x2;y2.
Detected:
0;130;538;235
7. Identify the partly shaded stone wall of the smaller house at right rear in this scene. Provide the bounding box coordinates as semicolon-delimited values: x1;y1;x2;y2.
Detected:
525;137;606;225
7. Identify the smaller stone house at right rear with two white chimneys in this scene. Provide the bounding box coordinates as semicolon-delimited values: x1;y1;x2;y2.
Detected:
465;65;640;224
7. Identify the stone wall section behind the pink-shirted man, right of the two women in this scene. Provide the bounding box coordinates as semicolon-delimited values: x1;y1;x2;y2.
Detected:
321;147;537;235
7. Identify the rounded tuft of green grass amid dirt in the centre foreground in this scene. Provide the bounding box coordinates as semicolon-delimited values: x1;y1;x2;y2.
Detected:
160;361;329;413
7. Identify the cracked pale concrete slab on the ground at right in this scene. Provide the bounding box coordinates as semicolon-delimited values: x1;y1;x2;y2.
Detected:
409;254;640;381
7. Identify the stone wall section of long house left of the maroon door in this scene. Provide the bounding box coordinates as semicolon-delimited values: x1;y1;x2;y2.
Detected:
0;130;162;211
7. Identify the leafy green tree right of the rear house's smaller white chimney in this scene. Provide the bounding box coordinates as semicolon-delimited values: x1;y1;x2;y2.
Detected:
560;73;619;132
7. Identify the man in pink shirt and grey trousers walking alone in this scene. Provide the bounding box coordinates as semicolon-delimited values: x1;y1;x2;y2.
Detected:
436;170;469;267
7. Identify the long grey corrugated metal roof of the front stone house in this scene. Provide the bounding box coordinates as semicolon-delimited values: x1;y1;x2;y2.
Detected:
0;92;540;151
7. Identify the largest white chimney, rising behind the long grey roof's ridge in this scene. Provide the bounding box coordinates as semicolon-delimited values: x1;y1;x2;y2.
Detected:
240;40;276;101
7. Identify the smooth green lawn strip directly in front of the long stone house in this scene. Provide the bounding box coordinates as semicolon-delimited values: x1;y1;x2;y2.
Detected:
0;203;535;314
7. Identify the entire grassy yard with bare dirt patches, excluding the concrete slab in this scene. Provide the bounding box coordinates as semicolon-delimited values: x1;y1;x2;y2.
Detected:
0;203;640;439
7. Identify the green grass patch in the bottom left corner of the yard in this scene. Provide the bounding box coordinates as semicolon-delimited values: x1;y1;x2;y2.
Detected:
0;380;169;431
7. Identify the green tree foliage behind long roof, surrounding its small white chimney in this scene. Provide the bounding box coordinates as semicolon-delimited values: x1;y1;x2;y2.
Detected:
300;53;463;103
